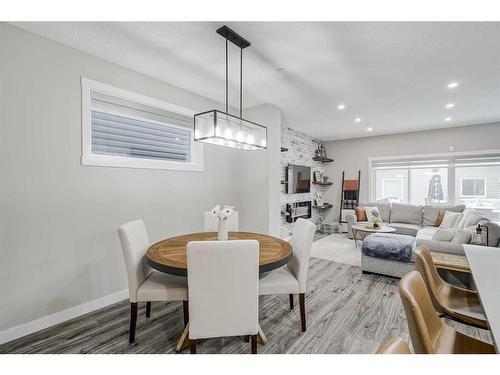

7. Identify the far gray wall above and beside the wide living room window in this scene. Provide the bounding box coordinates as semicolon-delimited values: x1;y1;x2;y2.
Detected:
325;123;500;220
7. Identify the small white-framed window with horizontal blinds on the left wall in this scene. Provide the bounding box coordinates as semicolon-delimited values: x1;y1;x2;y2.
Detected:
82;77;203;171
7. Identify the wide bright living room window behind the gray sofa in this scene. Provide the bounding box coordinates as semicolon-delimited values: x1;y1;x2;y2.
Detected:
369;150;500;220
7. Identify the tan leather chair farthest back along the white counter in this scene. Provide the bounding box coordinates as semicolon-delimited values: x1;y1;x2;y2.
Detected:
413;246;488;329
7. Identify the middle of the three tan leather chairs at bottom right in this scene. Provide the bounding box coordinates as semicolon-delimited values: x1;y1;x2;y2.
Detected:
399;271;495;354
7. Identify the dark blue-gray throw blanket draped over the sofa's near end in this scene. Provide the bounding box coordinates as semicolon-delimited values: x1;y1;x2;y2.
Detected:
361;233;415;262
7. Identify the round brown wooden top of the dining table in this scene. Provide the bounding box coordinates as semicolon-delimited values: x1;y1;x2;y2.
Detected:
146;232;292;276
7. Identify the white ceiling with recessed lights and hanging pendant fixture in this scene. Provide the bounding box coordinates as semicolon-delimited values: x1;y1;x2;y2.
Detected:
11;22;500;140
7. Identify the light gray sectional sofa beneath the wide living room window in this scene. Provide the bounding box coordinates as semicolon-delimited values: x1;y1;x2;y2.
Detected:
346;203;500;277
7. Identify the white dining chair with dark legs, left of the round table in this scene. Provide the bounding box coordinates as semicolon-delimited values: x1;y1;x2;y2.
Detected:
118;220;189;343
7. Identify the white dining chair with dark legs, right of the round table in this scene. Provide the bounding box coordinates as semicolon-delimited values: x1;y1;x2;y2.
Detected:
259;218;316;332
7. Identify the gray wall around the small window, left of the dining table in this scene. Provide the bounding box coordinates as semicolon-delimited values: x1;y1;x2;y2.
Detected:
0;23;279;331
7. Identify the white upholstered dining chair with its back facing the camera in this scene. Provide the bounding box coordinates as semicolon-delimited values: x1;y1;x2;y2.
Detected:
187;240;259;354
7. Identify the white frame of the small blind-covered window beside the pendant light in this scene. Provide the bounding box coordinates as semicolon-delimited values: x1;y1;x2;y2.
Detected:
81;77;204;172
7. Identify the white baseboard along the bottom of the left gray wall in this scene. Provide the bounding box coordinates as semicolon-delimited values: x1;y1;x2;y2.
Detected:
0;289;128;344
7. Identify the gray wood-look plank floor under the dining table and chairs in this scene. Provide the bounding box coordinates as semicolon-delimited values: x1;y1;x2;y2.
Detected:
0;258;491;354
